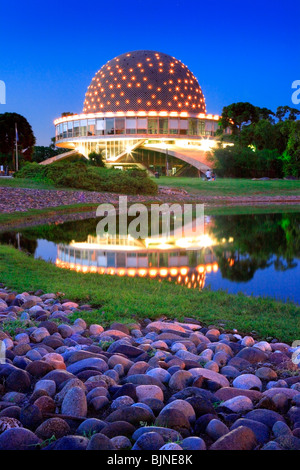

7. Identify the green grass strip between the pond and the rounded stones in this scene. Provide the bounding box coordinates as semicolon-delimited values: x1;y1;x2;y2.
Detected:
0;246;300;342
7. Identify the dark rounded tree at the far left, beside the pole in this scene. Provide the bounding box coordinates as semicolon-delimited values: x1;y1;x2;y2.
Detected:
0;113;35;167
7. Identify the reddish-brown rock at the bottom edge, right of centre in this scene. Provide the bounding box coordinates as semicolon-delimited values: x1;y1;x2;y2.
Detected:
210;426;257;450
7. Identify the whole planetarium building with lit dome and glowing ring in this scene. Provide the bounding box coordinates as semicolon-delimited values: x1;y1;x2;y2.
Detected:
52;51;226;175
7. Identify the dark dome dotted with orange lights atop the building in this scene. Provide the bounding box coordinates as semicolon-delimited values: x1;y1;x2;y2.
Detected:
83;51;206;114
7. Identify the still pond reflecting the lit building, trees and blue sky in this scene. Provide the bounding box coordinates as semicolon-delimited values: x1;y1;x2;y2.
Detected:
0;213;300;304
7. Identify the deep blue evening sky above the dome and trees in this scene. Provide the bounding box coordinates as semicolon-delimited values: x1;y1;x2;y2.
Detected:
0;0;300;145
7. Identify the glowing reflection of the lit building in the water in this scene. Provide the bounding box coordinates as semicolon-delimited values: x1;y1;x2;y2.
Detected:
56;231;234;289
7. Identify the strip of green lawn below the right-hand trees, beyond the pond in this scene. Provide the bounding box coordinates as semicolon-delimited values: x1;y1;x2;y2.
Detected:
157;176;300;196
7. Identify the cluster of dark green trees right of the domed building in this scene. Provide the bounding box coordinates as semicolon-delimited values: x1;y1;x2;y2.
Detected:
211;103;300;178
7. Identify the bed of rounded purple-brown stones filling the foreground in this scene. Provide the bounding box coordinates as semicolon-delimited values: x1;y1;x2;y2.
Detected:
0;288;300;451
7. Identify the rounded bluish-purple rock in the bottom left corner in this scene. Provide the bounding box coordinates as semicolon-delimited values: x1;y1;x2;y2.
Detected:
0;428;41;450
